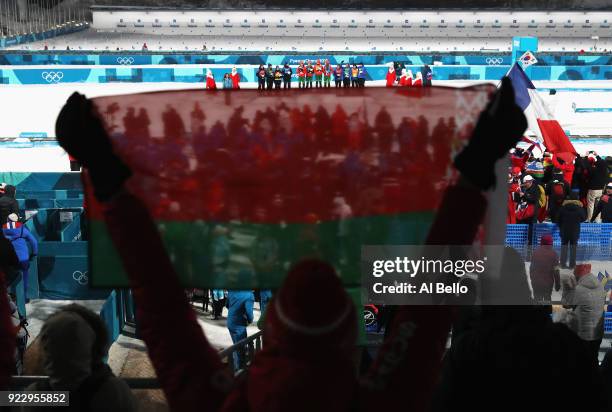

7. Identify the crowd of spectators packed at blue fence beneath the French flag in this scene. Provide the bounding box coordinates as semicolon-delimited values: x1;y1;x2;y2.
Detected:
506;145;612;262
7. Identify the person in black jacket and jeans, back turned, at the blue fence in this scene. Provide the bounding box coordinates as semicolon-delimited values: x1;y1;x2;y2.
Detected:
557;192;586;269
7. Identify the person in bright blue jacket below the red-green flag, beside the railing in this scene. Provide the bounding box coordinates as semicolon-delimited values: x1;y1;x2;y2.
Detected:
227;290;255;371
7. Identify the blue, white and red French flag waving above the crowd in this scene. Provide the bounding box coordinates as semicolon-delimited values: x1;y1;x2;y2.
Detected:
508;63;577;159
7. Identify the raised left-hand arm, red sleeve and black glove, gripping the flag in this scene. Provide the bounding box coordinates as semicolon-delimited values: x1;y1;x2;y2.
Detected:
56;93;231;412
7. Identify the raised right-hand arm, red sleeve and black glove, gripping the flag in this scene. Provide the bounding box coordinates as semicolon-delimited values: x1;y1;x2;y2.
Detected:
363;78;527;412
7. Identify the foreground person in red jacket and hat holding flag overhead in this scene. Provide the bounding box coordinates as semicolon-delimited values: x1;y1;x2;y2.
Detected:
51;78;526;412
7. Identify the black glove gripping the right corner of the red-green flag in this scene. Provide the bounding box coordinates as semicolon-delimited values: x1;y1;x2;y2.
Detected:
455;77;527;190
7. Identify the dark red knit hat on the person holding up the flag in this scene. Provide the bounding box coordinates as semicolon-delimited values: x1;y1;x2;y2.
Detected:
264;259;357;352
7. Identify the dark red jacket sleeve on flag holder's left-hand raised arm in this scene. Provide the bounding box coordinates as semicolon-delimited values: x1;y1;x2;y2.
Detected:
105;192;232;412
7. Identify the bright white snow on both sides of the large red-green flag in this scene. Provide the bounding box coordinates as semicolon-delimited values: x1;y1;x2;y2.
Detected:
0;81;612;172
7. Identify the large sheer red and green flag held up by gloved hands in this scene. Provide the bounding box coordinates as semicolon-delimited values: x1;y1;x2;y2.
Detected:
83;85;494;295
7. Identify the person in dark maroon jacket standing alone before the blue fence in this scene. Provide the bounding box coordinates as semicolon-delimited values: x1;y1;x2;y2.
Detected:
529;234;561;304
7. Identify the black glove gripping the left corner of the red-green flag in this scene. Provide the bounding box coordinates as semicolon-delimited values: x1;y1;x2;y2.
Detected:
55;93;132;201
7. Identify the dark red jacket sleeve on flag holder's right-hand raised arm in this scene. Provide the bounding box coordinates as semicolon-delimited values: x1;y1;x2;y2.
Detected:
363;182;487;412
